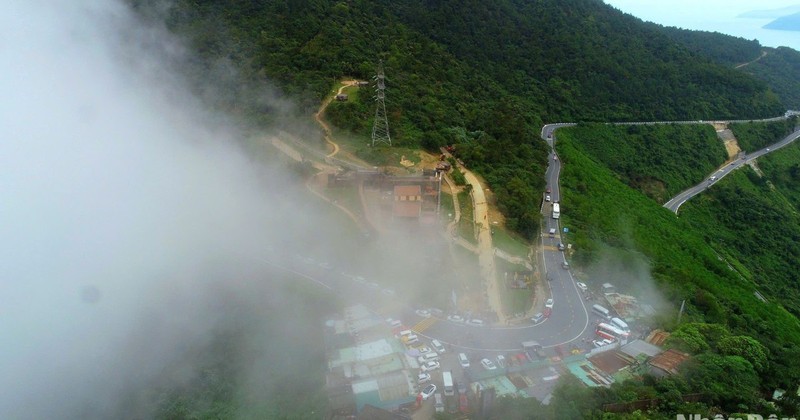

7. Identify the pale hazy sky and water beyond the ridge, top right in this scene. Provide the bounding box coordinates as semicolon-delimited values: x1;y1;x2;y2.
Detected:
606;0;800;49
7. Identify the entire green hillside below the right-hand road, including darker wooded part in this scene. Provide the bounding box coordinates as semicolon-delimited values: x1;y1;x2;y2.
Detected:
558;127;800;416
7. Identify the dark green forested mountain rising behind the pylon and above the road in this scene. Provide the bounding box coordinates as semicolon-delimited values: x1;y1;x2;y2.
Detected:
130;0;785;236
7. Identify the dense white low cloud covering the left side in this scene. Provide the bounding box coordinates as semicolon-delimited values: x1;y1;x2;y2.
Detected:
0;0;326;418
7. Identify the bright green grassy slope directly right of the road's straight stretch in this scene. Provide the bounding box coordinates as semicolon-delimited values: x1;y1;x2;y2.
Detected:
558;129;800;379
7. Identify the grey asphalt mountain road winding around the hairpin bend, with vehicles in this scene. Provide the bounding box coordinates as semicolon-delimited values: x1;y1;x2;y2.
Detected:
262;111;800;358
